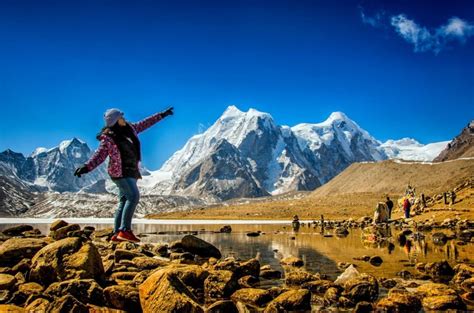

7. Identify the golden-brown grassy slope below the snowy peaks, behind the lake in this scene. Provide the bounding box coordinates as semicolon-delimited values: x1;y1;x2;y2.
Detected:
153;160;474;219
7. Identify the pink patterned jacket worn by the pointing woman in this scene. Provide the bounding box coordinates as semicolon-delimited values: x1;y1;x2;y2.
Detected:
85;113;163;178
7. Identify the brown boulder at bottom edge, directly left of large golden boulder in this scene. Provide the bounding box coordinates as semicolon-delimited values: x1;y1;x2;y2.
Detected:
104;285;142;313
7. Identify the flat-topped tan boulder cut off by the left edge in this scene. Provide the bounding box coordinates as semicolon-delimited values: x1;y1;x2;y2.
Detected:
0;238;48;266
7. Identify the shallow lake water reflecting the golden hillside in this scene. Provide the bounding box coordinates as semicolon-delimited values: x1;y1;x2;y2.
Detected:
0;223;474;279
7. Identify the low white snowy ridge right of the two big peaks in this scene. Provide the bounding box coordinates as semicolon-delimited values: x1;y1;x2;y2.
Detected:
380;138;449;161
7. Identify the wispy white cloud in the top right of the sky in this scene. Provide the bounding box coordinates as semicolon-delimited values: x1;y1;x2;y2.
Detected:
359;7;474;54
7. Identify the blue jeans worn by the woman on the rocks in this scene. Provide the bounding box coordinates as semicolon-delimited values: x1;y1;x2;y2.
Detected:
113;177;140;233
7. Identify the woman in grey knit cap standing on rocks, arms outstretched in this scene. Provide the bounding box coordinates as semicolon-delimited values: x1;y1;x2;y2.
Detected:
74;108;173;242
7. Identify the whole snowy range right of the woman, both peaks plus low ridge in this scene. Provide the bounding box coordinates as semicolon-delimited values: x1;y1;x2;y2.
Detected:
141;106;452;200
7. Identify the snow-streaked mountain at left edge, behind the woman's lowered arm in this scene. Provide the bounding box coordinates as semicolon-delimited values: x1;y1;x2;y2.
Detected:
0;138;106;192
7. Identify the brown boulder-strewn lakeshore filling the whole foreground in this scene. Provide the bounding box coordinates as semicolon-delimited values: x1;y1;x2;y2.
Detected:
0;218;474;313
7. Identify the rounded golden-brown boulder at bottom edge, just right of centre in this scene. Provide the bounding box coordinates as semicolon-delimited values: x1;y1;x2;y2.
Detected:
264;289;311;313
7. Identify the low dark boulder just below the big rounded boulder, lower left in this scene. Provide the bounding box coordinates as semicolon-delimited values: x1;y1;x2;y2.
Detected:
44;279;105;306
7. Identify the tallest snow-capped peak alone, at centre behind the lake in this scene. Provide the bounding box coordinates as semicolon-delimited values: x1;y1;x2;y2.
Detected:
144;106;320;200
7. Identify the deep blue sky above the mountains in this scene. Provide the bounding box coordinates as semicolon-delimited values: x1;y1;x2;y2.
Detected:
0;0;474;169
